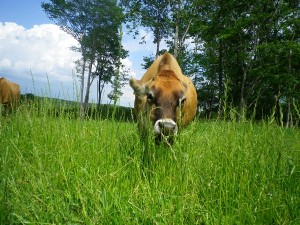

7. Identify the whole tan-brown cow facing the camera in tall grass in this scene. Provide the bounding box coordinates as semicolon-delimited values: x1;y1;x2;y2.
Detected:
129;52;197;142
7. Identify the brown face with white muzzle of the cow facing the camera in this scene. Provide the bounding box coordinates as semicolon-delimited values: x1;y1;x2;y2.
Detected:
130;70;186;136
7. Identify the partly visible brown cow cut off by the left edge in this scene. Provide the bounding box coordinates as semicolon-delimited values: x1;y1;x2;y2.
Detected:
0;77;20;107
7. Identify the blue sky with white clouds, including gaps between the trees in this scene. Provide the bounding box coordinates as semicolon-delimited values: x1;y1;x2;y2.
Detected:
0;0;159;107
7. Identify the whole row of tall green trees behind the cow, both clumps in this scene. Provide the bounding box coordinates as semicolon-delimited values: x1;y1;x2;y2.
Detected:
42;0;300;126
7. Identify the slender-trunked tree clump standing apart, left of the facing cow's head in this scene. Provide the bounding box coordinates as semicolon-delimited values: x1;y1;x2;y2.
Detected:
42;0;126;115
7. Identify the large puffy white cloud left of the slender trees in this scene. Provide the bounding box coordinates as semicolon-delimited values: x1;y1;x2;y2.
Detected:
0;23;80;82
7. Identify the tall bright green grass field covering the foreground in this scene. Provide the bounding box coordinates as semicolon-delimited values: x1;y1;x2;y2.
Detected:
0;100;300;224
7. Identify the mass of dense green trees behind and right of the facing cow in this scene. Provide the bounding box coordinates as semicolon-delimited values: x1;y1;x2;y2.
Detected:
121;0;300;123
